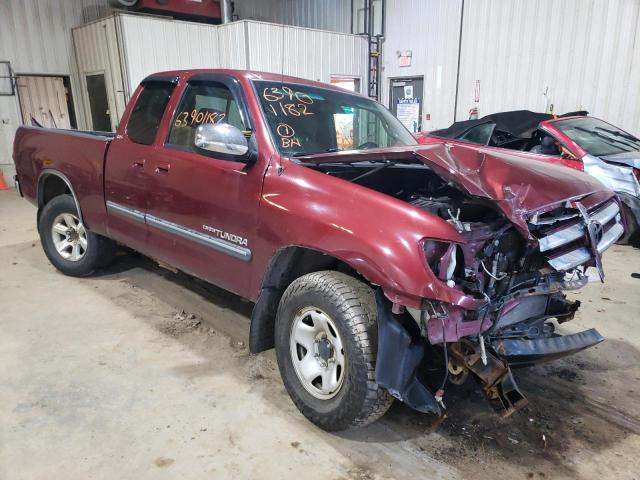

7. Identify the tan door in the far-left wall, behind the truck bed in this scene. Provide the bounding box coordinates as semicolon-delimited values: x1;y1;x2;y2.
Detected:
16;75;77;128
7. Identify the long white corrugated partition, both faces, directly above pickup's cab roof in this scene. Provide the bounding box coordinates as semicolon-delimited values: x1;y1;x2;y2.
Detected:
115;14;367;97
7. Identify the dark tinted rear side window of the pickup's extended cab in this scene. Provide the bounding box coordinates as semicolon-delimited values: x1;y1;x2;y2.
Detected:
127;81;174;145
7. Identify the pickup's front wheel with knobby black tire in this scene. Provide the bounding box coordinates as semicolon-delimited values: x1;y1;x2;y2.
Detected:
275;271;393;431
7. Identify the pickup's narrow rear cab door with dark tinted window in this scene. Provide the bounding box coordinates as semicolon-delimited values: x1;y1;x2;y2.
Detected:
105;77;175;253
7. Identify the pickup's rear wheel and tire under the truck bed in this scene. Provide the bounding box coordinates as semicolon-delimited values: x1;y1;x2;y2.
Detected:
38;195;116;277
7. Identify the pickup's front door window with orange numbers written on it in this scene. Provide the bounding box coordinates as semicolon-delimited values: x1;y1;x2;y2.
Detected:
167;82;245;153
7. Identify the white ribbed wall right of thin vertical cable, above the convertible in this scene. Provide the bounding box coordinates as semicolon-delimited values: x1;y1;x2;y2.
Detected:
457;0;640;134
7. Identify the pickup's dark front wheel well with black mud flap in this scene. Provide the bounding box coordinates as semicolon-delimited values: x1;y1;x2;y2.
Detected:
249;246;362;353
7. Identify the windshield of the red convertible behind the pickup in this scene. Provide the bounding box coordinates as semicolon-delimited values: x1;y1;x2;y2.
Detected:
553;117;640;157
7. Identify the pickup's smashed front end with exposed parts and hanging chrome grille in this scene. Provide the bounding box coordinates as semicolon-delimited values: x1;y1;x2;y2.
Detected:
376;193;624;416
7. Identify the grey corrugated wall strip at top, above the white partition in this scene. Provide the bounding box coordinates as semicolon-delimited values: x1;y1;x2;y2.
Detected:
235;0;351;33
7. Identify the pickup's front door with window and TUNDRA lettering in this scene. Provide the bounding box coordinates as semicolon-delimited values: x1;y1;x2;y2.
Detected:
147;74;265;296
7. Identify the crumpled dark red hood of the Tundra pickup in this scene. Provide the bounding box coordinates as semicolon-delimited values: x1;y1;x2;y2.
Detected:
302;143;614;236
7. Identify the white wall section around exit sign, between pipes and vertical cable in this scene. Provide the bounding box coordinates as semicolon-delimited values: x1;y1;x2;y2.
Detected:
381;0;462;130
